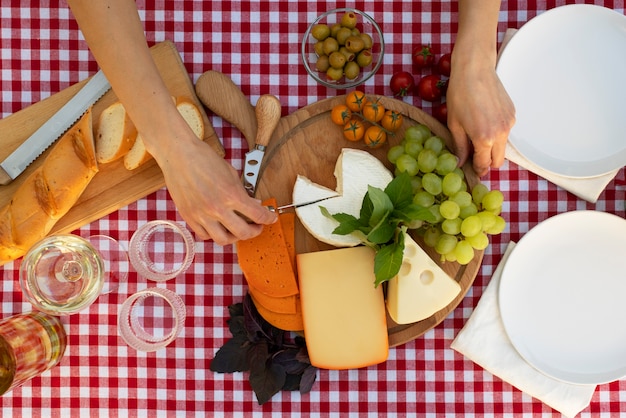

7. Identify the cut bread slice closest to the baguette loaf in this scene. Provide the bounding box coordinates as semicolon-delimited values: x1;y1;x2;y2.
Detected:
96;102;137;164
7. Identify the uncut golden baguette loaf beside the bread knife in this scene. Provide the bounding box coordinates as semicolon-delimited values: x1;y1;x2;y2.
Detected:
0;109;98;264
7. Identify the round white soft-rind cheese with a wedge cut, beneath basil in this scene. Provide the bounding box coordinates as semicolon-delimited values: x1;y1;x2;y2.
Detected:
293;148;393;247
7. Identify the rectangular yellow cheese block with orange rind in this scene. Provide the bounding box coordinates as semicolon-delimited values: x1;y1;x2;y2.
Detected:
297;247;389;370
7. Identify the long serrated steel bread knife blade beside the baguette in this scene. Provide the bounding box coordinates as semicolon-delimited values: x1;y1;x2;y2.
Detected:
0;70;111;185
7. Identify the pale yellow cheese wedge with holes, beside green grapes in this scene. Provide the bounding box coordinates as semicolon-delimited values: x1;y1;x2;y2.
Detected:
387;234;461;324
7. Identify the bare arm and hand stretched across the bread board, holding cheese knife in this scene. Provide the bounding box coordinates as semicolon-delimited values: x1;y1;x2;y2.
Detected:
68;0;276;245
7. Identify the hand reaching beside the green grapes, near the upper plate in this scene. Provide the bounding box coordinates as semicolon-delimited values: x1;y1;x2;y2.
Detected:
447;61;515;176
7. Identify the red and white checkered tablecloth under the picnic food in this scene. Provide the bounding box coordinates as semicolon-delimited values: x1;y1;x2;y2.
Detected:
0;0;626;417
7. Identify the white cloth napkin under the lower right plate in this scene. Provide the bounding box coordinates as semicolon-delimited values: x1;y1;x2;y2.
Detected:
451;242;596;417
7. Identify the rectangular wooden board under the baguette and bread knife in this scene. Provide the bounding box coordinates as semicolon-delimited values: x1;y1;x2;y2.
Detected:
0;41;224;242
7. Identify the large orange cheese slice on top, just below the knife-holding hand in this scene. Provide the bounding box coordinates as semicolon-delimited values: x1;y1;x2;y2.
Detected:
237;199;298;297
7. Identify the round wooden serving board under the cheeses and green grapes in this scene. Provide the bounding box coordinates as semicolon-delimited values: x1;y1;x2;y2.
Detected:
256;96;484;346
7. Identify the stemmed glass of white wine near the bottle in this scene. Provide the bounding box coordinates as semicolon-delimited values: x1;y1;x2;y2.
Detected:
20;234;129;316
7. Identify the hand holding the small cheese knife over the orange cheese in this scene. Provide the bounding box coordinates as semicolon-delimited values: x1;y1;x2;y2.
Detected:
159;139;277;245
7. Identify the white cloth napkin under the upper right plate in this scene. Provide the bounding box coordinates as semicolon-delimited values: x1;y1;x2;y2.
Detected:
500;29;619;203
